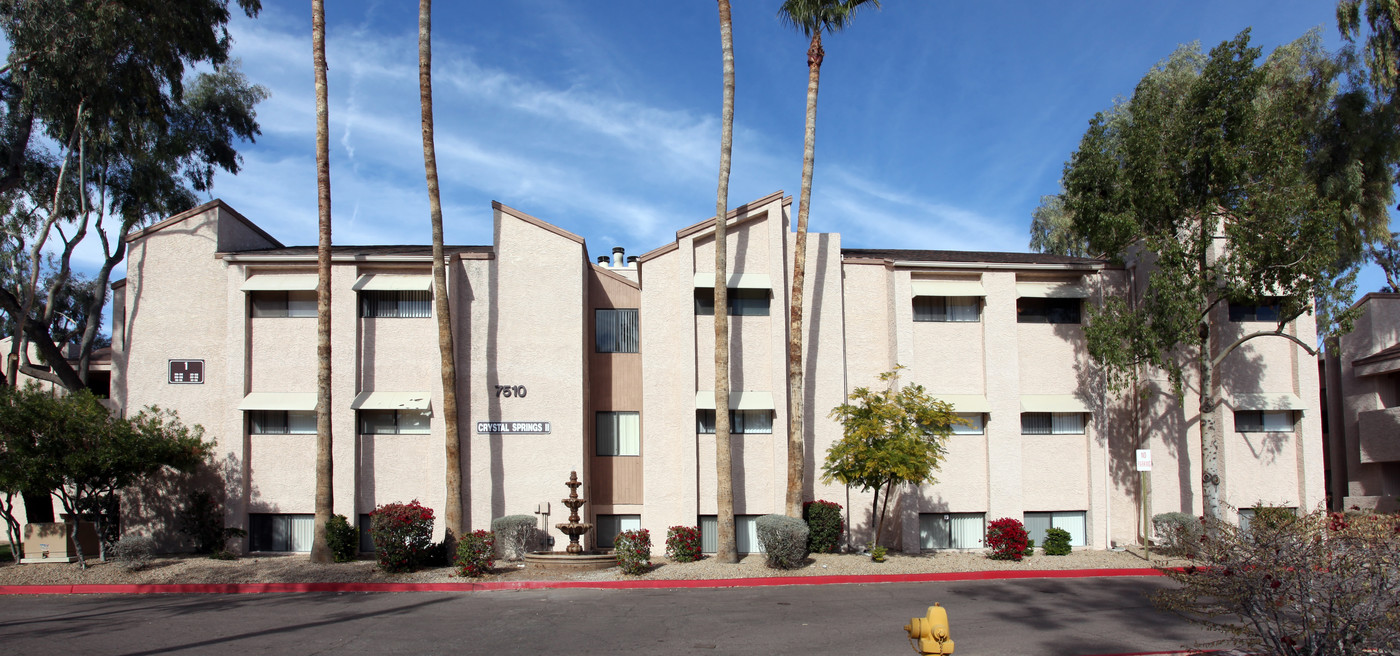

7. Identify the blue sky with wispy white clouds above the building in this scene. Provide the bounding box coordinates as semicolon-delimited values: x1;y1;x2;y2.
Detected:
183;0;1382;291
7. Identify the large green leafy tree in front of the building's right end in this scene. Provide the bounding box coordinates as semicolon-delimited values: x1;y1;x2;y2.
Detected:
1064;31;1390;518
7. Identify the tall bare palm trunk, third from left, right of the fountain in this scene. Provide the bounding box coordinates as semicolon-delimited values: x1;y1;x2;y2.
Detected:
714;0;739;562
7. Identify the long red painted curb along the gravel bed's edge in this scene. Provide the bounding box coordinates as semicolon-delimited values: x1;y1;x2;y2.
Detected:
0;568;1162;594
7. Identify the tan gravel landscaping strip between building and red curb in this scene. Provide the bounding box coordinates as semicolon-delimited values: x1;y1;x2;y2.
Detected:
0;550;1184;586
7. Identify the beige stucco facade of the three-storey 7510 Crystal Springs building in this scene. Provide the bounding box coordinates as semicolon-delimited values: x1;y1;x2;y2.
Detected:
112;193;1322;552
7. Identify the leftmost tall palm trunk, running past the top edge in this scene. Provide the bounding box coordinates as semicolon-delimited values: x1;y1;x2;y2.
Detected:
311;0;333;562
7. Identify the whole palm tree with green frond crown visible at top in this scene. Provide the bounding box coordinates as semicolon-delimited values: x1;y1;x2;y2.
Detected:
778;0;879;518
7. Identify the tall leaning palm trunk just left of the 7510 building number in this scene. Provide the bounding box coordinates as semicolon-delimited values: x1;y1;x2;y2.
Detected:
419;0;462;541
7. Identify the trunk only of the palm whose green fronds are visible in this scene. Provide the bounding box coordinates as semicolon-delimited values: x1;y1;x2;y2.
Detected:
785;31;825;518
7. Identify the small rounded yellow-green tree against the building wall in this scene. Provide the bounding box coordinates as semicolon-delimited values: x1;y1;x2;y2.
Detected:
822;366;966;544
